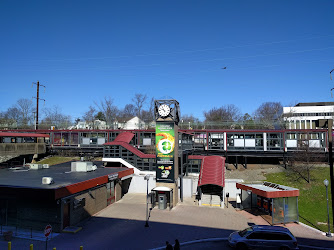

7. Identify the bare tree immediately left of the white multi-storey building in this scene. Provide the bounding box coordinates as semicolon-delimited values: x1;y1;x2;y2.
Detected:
254;102;283;129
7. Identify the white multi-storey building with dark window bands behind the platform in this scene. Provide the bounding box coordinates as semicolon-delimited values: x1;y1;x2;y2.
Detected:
283;102;334;129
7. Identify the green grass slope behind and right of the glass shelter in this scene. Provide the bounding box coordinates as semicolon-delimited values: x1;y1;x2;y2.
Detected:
266;167;333;232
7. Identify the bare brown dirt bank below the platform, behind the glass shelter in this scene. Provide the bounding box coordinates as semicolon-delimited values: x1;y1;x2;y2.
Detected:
225;164;285;181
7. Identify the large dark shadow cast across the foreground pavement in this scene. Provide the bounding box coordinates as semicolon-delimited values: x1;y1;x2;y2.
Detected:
0;217;334;250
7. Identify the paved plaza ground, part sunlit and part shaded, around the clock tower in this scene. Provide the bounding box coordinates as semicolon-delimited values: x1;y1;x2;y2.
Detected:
0;194;334;250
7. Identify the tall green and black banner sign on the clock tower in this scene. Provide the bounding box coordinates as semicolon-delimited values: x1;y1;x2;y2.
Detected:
155;122;177;183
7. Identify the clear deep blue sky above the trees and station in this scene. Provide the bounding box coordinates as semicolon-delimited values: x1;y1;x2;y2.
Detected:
0;0;334;120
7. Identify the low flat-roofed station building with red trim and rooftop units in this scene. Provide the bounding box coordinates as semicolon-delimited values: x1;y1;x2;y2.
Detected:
0;162;133;232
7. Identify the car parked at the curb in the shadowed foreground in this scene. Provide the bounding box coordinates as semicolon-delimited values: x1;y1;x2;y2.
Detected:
228;225;299;250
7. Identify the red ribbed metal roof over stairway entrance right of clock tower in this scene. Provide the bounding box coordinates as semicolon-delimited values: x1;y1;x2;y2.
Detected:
198;155;225;187
